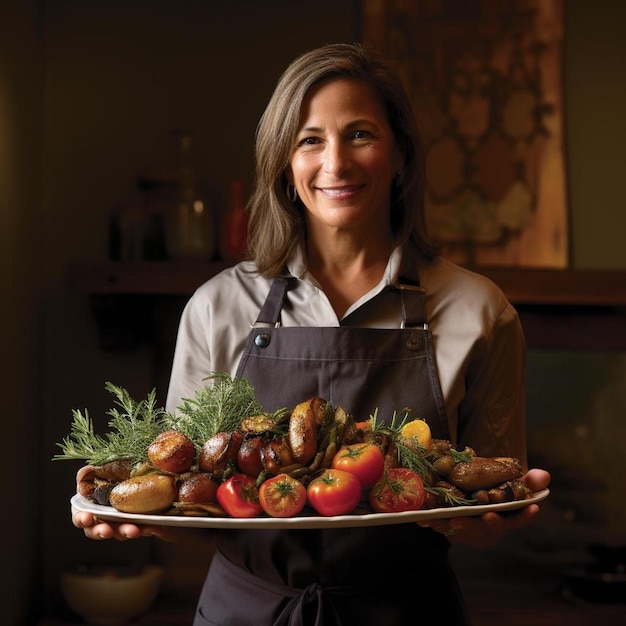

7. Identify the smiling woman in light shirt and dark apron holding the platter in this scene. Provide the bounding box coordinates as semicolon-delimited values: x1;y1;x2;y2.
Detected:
74;44;550;626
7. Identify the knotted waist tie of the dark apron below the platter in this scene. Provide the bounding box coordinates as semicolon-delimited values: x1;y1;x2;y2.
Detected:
213;550;378;626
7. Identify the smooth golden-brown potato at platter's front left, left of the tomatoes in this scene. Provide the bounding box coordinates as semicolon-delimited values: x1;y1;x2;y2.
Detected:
109;474;177;515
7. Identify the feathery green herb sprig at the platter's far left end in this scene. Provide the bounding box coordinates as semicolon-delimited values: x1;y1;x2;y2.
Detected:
53;382;168;465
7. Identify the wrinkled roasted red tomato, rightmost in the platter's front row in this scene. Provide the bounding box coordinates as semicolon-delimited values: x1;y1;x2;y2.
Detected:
369;467;425;513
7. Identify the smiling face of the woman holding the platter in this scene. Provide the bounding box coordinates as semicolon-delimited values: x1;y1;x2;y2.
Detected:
287;78;402;240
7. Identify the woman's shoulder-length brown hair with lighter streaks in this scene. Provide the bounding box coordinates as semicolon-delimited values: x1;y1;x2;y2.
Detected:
247;43;437;277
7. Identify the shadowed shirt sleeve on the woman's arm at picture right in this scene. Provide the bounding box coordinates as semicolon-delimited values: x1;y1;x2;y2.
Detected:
458;298;527;468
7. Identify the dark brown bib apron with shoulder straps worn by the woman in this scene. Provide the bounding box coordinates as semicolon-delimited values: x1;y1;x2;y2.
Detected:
194;278;469;626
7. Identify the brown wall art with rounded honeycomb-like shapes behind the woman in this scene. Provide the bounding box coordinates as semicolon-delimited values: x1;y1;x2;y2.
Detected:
362;0;569;268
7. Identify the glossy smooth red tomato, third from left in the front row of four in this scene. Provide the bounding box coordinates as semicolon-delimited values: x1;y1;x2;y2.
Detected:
307;469;361;516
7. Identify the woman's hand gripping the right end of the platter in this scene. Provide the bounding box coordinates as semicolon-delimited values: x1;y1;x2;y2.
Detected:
418;469;551;547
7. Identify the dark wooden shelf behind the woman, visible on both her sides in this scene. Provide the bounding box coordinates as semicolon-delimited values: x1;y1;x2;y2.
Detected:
69;261;626;350
